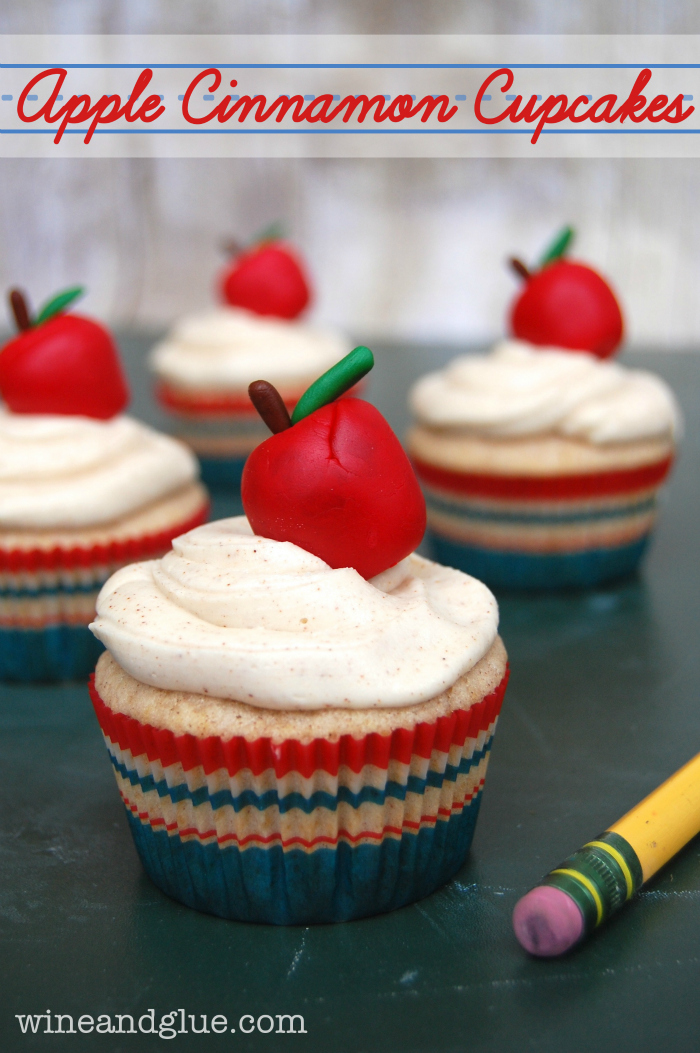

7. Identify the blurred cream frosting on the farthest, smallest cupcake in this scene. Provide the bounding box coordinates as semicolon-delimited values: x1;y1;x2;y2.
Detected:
149;307;351;391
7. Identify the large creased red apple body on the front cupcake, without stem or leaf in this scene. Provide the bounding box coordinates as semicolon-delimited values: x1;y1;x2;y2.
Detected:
241;398;425;578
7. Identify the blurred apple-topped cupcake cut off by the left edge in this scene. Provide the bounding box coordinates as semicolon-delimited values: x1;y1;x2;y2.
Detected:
0;290;207;680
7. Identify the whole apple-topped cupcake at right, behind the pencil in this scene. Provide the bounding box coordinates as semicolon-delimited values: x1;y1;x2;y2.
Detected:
408;229;680;589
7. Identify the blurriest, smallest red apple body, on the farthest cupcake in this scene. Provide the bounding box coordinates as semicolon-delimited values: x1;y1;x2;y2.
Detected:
221;241;311;318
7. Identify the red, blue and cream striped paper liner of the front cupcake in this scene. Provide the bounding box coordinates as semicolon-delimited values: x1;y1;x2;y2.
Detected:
91;673;507;925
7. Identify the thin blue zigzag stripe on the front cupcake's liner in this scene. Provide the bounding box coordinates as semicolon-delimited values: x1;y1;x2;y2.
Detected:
109;735;493;815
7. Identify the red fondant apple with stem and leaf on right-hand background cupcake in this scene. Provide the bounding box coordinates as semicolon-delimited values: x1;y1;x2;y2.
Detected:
511;229;623;358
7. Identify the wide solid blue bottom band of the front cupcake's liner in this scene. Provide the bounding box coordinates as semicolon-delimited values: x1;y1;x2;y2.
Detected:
126;794;481;925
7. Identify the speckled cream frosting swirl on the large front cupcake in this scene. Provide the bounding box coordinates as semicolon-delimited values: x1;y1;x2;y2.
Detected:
91;516;498;710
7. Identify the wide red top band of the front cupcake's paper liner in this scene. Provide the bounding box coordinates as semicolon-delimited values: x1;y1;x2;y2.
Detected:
89;669;509;778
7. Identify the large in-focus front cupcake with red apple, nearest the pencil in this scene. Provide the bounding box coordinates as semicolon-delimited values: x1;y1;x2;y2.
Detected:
88;347;507;925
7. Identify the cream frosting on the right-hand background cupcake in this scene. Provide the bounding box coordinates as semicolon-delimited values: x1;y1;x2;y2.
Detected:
411;340;681;444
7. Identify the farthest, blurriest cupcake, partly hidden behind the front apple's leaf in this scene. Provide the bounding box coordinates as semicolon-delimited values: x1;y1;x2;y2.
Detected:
149;232;348;492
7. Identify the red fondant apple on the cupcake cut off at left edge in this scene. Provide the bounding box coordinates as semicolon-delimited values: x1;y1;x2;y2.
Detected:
0;294;128;420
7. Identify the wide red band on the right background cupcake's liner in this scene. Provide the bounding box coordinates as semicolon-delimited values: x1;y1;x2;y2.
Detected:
413;457;674;501
